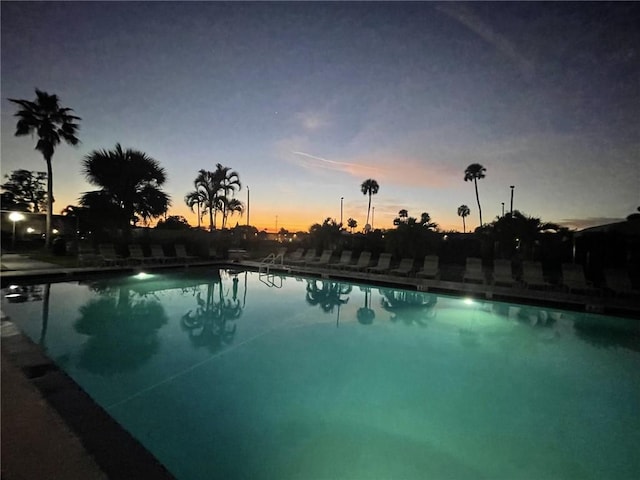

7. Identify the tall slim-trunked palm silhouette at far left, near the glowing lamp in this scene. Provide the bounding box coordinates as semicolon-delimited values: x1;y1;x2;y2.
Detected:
9;88;81;248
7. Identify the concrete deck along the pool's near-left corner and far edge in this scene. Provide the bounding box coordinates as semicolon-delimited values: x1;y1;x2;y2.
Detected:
1;254;640;480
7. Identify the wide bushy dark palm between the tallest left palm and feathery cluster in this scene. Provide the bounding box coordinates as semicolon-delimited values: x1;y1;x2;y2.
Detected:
80;144;170;235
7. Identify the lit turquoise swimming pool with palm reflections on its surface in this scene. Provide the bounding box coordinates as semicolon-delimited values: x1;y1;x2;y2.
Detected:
3;270;640;480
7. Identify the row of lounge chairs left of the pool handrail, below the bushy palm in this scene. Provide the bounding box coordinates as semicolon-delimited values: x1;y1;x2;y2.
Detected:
78;243;199;266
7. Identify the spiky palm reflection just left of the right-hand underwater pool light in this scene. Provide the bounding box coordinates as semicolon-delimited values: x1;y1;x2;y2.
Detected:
380;289;438;327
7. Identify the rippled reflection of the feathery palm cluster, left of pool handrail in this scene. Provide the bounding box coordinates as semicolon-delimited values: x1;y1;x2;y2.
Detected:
180;278;242;352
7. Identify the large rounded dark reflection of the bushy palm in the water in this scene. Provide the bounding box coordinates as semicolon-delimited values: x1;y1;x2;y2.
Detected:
74;287;167;375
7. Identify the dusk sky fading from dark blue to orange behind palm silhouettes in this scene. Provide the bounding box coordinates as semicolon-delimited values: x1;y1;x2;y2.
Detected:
1;1;640;231
